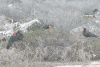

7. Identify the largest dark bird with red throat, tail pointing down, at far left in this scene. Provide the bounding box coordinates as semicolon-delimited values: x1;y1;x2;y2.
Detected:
7;31;24;49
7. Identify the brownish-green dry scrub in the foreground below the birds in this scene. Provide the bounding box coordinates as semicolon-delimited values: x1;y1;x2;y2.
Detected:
0;24;100;67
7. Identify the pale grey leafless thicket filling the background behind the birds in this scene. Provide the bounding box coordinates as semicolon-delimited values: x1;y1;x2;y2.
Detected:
0;0;100;30
